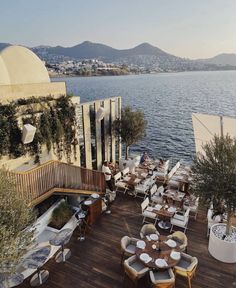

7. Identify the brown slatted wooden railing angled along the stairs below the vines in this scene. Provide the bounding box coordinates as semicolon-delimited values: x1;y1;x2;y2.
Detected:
8;161;106;203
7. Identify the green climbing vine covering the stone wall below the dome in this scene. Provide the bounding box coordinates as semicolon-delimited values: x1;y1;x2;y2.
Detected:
0;96;78;163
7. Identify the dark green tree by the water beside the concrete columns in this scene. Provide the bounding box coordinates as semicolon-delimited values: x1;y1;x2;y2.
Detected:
113;106;147;159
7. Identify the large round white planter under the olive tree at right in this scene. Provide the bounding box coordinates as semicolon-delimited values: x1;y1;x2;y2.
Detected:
208;223;236;263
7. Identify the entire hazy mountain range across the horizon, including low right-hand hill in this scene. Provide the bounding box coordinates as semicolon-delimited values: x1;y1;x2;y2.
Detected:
0;41;236;71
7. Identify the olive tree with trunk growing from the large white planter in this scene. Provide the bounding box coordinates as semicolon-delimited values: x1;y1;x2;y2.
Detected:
193;135;236;234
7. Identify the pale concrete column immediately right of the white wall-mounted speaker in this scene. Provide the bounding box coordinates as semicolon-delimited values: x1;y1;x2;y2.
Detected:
104;99;111;161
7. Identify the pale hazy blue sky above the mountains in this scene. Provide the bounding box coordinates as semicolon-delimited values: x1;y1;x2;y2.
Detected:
0;0;236;58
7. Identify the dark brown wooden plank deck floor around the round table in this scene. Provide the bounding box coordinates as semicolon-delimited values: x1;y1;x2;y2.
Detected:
18;195;236;288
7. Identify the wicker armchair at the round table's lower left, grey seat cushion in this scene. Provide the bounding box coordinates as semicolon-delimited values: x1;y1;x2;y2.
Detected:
124;255;149;287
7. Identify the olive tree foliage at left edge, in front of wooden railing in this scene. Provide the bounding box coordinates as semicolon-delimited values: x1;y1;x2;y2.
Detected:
0;170;35;274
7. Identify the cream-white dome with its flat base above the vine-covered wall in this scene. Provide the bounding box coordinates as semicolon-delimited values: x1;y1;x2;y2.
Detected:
0;46;66;102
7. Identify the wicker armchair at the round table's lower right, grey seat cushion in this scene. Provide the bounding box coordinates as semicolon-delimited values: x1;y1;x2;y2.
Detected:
174;253;198;288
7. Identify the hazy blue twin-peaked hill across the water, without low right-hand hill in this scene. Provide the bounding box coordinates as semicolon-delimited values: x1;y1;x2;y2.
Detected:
32;41;211;71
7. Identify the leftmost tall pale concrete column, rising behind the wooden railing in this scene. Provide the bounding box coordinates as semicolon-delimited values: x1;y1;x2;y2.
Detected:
82;104;92;169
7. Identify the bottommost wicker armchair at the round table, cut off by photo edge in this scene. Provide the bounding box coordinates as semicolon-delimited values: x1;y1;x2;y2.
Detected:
149;269;175;288
